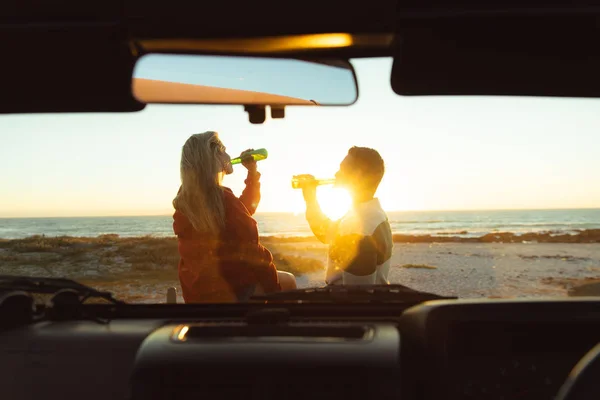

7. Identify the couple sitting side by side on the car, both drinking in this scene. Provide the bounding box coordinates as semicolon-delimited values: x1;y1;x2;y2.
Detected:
173;132;393;303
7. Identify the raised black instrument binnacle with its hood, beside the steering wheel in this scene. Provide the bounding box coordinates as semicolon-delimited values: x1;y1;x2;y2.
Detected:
400;299;600;400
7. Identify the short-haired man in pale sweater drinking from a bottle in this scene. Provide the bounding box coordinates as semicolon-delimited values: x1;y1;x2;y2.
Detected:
302;146;393;285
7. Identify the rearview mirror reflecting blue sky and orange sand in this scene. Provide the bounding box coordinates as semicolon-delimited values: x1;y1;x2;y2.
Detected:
132;54;358;106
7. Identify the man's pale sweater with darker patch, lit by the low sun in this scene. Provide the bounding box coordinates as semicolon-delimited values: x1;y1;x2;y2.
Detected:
306;198;393;285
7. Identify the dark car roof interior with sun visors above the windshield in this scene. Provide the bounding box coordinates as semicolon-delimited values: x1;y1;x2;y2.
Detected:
0;0;600;113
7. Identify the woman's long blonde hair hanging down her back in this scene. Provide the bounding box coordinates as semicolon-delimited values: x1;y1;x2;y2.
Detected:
173;131;230;234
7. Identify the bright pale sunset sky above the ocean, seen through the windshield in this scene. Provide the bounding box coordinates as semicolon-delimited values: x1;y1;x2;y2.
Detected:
0;59;600;217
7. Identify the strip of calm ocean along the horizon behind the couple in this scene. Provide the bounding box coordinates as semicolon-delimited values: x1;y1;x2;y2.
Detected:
0;209;600;239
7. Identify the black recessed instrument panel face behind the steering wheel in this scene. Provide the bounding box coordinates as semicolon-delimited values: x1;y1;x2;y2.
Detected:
446;321;600;399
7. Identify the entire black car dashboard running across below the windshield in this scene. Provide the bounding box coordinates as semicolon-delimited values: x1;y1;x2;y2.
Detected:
0;299;600;400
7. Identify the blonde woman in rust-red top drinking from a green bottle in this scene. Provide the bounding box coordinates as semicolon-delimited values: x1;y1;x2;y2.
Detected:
173;132;296;303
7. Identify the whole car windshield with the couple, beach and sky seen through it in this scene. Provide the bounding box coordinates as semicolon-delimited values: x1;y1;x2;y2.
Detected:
0;58;600;303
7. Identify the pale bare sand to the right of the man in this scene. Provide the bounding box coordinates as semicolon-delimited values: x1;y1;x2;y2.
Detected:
292;243;600;297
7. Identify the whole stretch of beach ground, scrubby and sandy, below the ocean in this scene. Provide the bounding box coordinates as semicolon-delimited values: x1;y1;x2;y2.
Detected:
0;235;600;303
